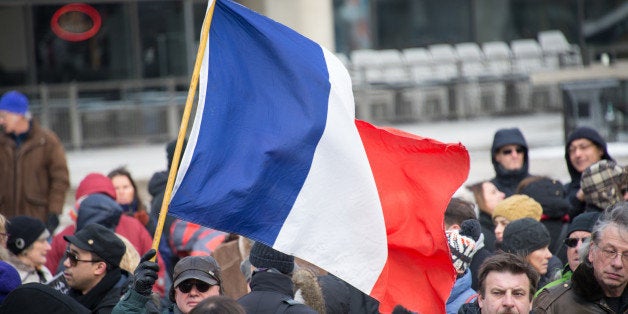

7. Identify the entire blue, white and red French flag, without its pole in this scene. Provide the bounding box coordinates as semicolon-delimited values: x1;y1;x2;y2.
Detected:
169;0;469;313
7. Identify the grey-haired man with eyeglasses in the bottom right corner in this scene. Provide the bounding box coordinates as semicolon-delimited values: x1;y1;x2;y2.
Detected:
533;202;628;313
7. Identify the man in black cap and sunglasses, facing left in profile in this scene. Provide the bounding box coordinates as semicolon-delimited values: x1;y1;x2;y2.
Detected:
63;224;126;313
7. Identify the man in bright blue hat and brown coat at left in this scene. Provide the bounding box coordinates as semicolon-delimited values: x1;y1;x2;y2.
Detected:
0;91;70;232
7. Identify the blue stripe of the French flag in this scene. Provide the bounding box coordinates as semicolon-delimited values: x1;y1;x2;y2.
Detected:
169;1;330;245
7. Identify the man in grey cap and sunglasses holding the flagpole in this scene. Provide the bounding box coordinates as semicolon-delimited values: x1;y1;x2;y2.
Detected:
113;255;223;314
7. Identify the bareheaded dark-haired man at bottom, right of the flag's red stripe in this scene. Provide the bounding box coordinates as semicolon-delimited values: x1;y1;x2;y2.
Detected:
458;253;539;314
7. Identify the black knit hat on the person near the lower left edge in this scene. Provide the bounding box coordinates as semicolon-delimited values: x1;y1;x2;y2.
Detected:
7;216;50;255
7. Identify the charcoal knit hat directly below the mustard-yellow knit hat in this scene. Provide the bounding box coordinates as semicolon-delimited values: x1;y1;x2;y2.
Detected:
502;218;550;256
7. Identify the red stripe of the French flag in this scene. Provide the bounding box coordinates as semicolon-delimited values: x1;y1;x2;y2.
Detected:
356;120;469;313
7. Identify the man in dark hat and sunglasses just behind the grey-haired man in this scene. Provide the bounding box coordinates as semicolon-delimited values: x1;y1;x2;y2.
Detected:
536;212;600;295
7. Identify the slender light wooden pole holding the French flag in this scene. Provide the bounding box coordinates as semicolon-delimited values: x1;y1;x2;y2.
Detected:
150;0;217;255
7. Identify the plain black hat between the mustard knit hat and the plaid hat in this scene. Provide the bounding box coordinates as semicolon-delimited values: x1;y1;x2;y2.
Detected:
519;177;571;219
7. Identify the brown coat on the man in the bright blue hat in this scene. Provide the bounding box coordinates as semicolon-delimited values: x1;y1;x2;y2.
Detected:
0;121;70;223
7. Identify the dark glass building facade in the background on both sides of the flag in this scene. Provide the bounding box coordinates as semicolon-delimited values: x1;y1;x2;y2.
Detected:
0;0;628;90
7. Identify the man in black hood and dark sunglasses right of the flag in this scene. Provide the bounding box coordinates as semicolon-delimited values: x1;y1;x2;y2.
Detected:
491;128;530;197
